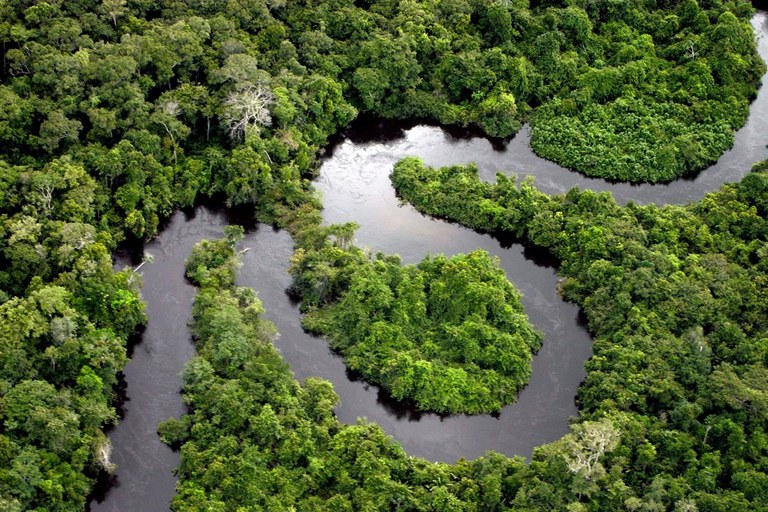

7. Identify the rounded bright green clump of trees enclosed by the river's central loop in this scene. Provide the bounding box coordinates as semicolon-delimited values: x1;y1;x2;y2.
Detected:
292;244;541;414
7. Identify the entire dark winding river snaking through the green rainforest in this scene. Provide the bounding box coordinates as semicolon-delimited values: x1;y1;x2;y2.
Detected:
90;11;768;512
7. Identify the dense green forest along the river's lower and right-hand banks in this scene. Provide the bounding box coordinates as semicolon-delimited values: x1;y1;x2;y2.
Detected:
160;154;768;511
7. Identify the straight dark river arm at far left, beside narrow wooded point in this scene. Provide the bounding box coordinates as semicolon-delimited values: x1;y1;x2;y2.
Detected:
90;208;227;512
